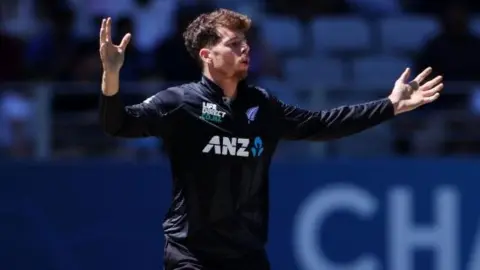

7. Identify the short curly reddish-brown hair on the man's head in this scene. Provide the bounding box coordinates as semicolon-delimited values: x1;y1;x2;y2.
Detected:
183;9;252;63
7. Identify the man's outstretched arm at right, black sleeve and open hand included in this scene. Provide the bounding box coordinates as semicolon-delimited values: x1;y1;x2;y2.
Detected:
270;68;443;140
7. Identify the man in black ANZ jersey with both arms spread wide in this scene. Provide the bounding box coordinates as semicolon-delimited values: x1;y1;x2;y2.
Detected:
100;9;443;270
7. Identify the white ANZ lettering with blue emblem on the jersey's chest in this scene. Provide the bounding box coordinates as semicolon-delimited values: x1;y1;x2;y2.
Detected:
202;136;263;157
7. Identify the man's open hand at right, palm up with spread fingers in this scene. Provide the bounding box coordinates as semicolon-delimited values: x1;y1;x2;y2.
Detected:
388;67;443;114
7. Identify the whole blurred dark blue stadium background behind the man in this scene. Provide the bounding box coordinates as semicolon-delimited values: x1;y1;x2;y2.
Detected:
0;0;480;270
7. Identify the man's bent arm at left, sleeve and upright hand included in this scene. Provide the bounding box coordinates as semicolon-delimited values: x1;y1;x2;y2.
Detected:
100;18;181;138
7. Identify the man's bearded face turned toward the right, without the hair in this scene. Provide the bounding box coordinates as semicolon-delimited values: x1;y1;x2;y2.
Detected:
200;27;250;79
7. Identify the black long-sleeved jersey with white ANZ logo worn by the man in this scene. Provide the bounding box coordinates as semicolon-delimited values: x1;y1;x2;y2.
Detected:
100;77;394;264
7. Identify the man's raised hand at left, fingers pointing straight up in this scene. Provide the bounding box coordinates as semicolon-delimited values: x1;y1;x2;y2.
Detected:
100;18;132;72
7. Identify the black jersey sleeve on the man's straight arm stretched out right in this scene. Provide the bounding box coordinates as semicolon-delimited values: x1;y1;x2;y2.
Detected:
270;97;394;141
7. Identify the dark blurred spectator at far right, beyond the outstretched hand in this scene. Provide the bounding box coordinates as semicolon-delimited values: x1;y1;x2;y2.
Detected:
411;2;480;155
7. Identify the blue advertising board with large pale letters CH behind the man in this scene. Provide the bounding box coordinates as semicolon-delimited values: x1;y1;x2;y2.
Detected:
0;159;480;270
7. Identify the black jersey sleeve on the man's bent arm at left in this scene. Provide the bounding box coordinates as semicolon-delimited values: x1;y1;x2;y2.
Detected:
100;88;183;138
